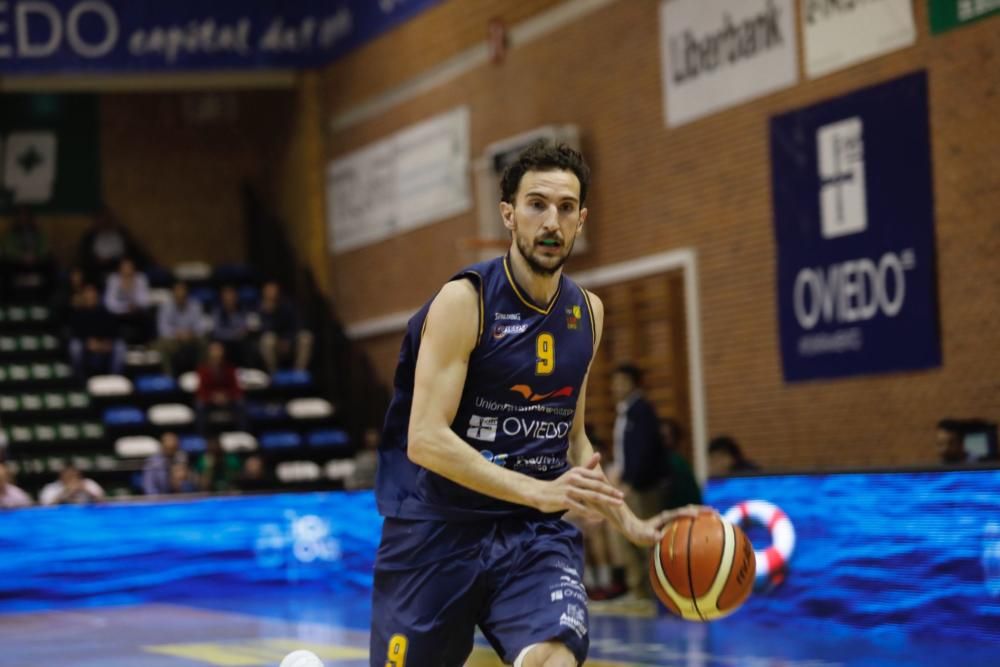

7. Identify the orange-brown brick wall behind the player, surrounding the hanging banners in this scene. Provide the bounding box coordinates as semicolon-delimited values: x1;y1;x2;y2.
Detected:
324;0;1000;468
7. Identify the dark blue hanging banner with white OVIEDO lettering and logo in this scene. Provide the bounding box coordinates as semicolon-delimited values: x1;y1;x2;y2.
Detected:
771;72;941;381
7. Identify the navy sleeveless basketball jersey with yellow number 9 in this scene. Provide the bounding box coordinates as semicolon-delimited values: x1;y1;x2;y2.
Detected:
375;257;596;520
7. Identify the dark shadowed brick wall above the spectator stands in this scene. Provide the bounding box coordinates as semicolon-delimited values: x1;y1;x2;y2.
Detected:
27;92;291;266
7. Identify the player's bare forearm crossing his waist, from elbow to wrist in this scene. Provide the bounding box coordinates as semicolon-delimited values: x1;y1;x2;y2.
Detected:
407;429;542;507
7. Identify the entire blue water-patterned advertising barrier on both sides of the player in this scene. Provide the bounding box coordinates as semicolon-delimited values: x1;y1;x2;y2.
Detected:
0;470;1000;666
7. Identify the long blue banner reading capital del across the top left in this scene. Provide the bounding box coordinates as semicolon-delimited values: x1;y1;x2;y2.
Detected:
0;0;440;74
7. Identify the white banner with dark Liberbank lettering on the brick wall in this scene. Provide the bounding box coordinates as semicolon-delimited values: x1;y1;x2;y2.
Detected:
660;0;799;127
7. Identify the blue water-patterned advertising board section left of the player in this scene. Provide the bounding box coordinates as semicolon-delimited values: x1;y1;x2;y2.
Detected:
0;493;382;612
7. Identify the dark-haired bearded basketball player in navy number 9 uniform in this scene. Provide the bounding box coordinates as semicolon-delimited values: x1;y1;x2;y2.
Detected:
371;142;700;667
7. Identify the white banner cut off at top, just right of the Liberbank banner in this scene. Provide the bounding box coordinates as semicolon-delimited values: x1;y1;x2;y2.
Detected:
802;0;917;79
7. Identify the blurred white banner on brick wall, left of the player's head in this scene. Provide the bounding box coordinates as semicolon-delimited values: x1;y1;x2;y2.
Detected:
326;107;472;252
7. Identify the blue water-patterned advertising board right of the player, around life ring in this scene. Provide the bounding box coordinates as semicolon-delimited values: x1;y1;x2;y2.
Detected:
706;470;1000;648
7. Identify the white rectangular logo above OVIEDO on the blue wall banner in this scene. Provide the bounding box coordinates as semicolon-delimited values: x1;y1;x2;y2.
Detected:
816;116;868;239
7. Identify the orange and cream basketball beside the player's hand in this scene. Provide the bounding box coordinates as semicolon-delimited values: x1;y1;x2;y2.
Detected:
649;510;757;621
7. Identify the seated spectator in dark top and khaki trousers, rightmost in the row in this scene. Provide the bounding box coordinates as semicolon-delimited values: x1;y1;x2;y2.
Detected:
257;281;313;373
